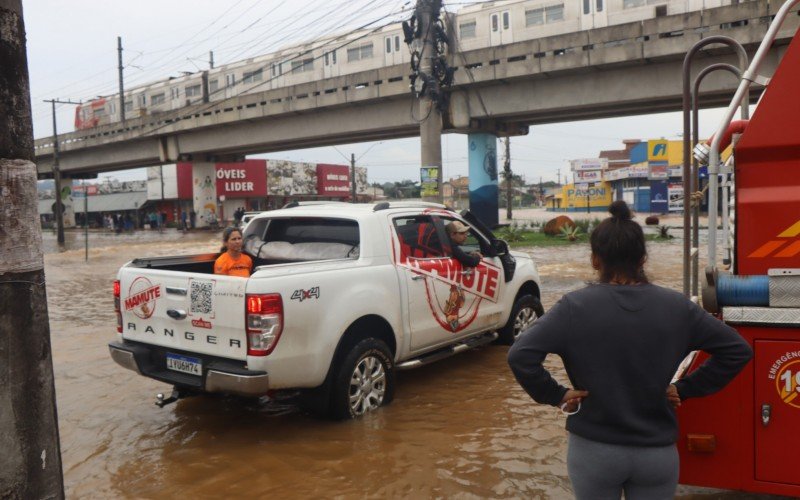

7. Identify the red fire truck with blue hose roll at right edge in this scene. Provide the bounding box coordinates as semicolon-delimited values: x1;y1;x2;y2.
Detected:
678;0;800;497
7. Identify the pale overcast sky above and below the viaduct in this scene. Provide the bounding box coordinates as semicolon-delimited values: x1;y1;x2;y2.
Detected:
23;0;722;183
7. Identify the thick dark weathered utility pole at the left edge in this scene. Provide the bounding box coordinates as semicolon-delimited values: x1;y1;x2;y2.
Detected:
0;0;64;499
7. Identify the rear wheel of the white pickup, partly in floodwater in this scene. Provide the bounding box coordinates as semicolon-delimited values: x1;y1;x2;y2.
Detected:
330;338;394;420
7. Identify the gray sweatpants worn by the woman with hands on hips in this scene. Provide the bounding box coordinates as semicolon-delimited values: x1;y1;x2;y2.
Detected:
567;433;678;500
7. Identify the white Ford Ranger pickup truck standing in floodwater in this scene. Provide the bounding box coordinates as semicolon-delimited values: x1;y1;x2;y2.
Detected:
109;202;544;419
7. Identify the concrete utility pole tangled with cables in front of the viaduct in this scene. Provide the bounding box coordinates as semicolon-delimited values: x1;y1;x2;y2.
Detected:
416;0;444;203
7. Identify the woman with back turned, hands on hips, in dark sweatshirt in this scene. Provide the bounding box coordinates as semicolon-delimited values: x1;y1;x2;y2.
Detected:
508;201;753;500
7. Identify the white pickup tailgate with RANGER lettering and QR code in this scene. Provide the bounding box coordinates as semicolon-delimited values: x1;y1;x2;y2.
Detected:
119;267;247;360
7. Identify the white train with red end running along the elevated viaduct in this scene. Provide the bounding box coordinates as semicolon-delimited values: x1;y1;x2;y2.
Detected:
75;0;740;130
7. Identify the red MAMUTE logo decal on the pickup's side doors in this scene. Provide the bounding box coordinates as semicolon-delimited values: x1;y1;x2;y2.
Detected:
398;257;500;333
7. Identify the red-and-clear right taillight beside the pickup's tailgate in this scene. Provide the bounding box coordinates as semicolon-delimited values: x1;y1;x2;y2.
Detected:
245;293;283;356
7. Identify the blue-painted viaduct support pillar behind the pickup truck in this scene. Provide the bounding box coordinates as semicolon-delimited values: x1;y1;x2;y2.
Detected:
467;133;500;228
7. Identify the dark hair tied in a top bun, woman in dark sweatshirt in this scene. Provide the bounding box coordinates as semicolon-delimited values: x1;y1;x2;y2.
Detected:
589;201;647;283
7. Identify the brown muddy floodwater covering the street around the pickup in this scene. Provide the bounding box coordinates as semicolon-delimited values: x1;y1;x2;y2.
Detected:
44;230;776;499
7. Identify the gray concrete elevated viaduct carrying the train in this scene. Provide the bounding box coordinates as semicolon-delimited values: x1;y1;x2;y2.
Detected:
35;1;800;177
